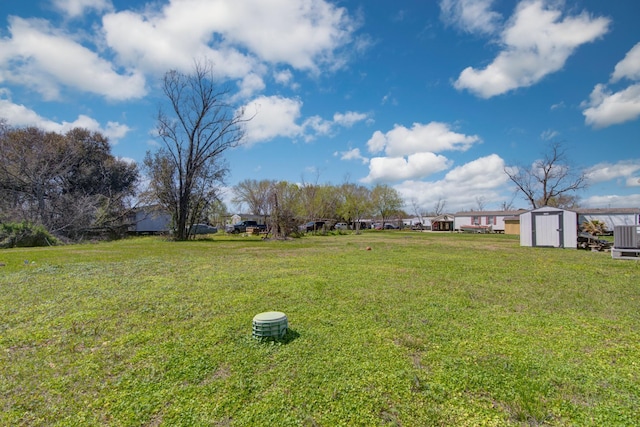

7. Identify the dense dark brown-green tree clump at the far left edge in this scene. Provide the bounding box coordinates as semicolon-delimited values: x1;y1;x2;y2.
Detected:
0;122;139;240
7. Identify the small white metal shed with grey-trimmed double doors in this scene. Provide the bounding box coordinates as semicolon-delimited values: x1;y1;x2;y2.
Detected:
520;206;578;249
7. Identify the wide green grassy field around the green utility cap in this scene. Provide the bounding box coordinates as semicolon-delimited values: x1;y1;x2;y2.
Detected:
0;231;640;426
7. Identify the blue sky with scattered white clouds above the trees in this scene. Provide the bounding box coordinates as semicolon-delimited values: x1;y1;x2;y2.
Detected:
0;0;640;212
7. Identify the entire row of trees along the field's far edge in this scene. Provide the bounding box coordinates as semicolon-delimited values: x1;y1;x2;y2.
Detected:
0;61;586;246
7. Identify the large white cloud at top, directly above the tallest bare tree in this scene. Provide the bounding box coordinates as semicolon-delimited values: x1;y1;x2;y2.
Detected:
103;0;355;78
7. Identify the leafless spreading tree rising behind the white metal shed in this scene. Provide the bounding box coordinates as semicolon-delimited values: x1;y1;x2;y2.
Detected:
504;142;587;209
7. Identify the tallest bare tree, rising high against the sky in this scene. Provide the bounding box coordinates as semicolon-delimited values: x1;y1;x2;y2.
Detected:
145;62;246;240
